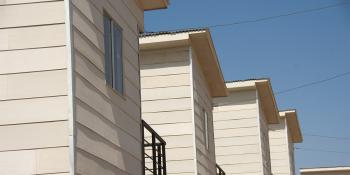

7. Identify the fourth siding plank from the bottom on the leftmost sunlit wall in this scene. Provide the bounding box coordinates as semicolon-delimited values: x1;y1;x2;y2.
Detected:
0;70;68;100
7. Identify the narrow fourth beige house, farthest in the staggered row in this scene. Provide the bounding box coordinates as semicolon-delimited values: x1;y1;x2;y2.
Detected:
269;110;303;175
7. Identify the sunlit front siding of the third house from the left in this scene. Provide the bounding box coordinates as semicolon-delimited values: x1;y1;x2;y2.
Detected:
214;90;263;175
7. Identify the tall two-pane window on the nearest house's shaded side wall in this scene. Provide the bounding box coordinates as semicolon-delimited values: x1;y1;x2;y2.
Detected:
104;15;124;94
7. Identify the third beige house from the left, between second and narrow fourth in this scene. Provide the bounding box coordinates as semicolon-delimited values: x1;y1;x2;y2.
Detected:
214;79;279;175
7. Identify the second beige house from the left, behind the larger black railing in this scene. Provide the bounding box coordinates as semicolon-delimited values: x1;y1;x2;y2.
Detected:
140;29;227;175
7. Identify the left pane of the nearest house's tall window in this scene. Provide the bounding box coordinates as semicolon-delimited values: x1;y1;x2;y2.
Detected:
103;16;113;86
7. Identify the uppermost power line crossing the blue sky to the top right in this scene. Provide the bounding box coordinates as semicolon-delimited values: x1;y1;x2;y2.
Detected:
207;2;350;28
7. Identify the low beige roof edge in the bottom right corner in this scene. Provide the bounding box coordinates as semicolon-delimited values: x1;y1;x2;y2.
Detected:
300;167;350;175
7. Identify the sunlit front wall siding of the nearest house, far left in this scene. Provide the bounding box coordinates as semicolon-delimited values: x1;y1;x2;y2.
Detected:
0;0;69;175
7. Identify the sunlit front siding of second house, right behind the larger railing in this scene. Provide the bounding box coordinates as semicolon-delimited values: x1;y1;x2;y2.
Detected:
140;47;195;174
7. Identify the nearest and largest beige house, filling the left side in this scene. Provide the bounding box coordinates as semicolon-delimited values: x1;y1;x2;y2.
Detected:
0;0;167;175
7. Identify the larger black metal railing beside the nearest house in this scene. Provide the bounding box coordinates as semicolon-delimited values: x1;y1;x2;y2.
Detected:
141;120;167;175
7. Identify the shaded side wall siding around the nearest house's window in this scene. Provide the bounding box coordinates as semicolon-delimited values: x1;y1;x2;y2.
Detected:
72;0;143;175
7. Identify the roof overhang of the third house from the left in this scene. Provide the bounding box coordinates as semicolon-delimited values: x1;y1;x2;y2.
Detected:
226;78;279;124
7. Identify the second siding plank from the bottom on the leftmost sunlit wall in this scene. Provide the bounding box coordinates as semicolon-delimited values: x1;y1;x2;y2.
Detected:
0;121;68;151
